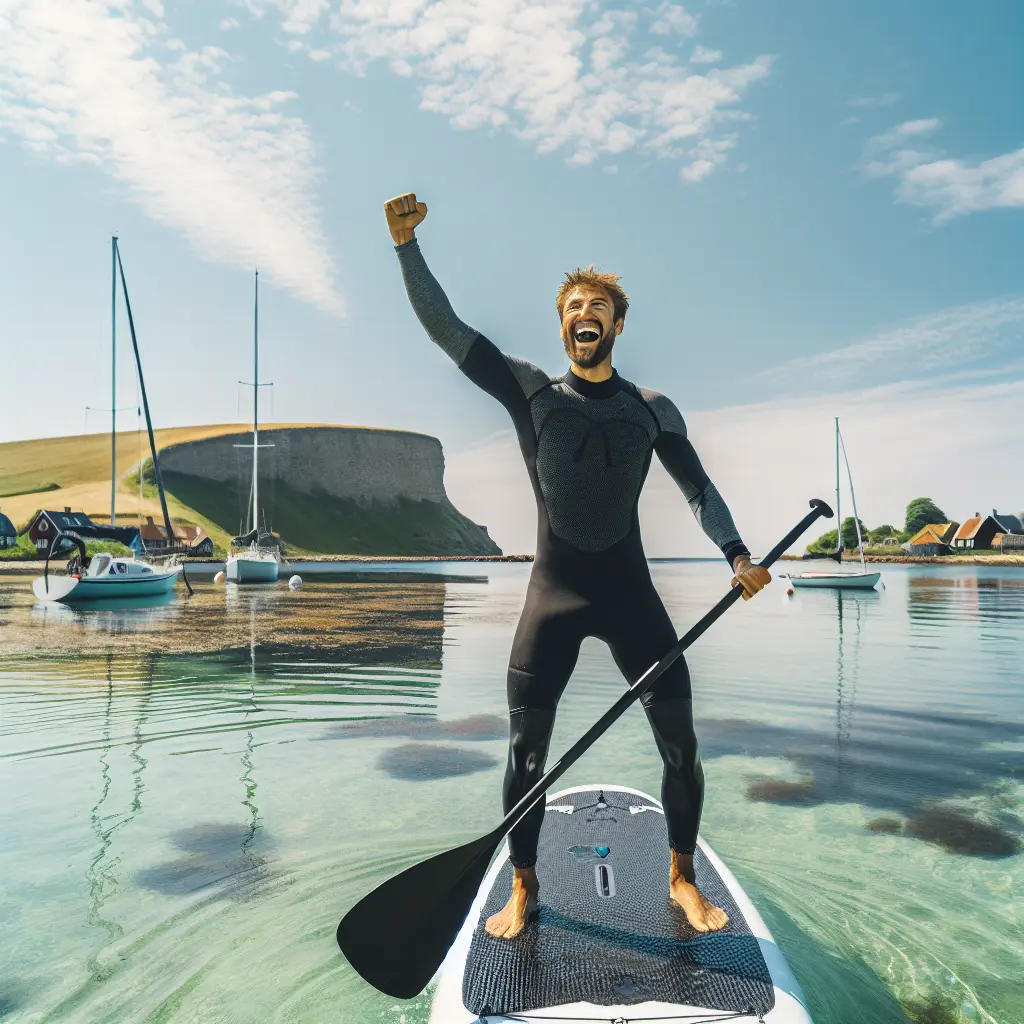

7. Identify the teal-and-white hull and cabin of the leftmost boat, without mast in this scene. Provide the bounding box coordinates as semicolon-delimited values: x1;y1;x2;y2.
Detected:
32;532;180;604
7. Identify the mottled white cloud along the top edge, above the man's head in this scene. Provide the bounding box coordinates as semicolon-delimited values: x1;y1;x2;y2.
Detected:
250;0;772;181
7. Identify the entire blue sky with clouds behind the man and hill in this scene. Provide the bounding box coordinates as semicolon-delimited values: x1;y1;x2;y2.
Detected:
0;0;1024;555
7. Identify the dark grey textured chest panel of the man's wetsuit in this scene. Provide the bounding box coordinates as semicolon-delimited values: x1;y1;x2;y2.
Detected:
530;383;657;552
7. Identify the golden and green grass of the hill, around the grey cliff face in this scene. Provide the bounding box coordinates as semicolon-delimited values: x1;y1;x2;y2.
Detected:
0;423;498;555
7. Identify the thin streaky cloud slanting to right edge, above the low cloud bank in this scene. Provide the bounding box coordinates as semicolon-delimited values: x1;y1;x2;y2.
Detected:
761;295;1024;390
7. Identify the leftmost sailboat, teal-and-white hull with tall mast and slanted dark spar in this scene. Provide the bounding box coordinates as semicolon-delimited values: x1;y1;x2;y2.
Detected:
32;236;185;604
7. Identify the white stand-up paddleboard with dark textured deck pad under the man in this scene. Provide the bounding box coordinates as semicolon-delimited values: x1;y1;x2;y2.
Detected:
430;785;811;1024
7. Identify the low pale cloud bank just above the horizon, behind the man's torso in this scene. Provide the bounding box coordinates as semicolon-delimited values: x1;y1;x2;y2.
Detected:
445;379;1024;556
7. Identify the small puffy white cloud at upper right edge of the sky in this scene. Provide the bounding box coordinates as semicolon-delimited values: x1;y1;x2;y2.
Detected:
863;118;1024;224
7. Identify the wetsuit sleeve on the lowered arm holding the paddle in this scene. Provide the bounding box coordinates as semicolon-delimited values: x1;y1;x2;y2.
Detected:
640;390;751;565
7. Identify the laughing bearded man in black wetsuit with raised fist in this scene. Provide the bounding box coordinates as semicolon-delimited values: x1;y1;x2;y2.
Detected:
384;193;771;938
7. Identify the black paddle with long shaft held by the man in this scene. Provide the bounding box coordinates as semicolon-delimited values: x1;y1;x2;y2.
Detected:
338;498;834;999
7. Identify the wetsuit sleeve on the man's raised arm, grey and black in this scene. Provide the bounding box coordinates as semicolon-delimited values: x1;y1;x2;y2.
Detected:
395;239;551;419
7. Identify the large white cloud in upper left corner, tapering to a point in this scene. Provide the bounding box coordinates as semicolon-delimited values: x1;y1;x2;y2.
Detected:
0;0;341;311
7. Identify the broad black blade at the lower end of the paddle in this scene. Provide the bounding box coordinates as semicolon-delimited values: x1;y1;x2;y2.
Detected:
338;833;504;999
